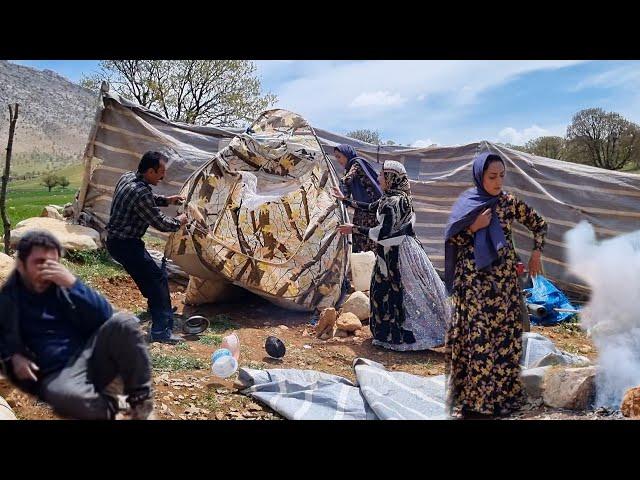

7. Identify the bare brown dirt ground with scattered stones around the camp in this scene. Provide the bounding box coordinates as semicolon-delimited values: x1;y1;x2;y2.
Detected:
0;276;617;420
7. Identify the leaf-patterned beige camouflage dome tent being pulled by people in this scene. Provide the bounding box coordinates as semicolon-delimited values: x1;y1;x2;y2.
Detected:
160;110;349;310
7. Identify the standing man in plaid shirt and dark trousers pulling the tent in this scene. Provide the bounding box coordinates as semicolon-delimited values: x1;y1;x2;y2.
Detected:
107;152;187;344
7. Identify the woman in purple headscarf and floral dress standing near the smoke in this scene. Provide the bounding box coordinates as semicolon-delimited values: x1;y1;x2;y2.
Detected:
445;152;547;418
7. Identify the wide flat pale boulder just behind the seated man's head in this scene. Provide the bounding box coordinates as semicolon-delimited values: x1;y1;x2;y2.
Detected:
11;217;101;251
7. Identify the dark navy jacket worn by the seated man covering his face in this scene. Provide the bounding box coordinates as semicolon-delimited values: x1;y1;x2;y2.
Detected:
0;271;113;394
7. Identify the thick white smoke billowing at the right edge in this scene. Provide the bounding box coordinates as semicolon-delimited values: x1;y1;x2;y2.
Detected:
565;222;640;408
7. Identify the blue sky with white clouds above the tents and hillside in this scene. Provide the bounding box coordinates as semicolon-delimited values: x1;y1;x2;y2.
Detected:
10;60;640;146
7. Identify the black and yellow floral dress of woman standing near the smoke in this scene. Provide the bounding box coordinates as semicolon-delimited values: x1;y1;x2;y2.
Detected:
446;193;547;415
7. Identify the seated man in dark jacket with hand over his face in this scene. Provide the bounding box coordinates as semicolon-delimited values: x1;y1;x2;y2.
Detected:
0;231;153;420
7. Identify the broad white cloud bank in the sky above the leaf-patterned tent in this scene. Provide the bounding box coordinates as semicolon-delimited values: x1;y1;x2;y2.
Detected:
258;60;579;143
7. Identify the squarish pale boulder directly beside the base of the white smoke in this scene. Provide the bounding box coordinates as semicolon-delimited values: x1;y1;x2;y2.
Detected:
542;366;596;410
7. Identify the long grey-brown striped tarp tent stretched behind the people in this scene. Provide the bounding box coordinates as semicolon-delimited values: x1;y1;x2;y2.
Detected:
76;83;640;300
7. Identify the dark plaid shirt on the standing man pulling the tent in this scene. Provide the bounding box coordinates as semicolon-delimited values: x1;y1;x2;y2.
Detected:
107;172;180;239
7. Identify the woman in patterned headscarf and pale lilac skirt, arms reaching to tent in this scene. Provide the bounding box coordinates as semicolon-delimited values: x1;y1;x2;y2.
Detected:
334;161;451;351
